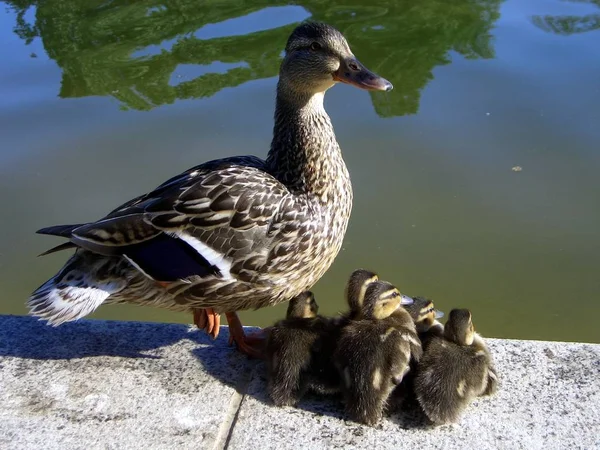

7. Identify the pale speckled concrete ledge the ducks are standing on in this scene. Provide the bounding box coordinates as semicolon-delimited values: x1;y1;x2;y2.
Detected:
0;316;600;449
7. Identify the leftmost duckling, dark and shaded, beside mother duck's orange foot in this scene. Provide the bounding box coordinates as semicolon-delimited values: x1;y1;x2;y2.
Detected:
265;291;339;406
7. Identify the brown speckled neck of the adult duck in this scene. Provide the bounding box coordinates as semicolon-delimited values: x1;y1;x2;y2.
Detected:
267;81;349;201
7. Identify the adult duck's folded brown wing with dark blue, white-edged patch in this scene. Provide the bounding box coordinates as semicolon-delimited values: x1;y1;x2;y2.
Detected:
40;158;298;281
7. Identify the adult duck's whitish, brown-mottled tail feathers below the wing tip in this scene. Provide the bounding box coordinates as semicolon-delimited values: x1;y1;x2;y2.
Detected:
27;250;126;326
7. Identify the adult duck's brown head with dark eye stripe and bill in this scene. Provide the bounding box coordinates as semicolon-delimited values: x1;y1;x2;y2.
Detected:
279;22;392;95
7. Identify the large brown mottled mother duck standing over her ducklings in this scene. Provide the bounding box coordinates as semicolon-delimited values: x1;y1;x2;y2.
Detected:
28;22;392;356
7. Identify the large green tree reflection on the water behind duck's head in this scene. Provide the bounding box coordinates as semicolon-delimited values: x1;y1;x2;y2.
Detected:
7;0;501;116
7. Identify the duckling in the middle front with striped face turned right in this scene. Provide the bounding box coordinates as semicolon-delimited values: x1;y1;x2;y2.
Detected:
334;281;421;425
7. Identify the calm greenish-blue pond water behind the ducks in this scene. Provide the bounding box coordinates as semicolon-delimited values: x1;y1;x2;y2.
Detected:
0;0;600;342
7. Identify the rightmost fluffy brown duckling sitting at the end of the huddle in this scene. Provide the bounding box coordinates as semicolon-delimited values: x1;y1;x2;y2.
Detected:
414;309;498;424
